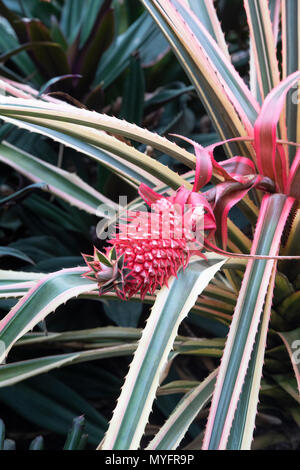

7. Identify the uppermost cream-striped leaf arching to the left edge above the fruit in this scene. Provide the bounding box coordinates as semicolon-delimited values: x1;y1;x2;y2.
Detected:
0;97;196;178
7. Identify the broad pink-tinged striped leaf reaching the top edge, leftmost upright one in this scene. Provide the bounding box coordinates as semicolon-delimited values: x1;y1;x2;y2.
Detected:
142;0;259;155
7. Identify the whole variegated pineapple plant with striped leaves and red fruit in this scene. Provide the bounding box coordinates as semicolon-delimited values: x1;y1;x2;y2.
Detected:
0;0;300;450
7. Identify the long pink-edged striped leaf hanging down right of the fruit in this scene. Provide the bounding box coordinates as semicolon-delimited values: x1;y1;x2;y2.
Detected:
203;194;294;450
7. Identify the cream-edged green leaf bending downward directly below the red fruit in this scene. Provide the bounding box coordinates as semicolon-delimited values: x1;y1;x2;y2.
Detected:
99;259;226;450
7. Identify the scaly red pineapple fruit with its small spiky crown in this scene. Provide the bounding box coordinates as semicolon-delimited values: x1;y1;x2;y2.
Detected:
84;192;203;299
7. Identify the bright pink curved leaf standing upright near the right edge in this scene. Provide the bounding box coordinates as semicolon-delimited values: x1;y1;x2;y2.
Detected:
254;71;300;192
